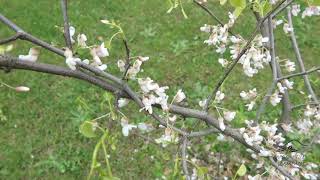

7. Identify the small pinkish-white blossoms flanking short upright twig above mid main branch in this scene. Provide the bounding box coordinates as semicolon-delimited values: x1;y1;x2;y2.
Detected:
118;56;149;79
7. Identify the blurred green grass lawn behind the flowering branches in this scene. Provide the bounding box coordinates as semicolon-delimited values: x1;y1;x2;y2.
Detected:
0;0;320;179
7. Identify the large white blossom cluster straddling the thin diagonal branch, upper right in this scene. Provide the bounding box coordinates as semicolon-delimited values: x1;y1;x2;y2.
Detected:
200;13;271;77
